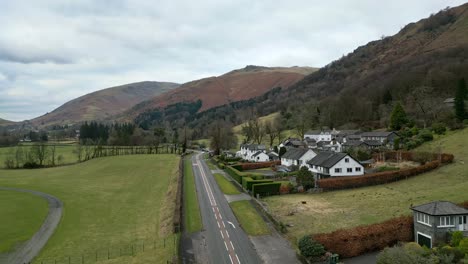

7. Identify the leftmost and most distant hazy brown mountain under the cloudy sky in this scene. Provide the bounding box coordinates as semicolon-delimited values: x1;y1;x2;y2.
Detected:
31;82;179;126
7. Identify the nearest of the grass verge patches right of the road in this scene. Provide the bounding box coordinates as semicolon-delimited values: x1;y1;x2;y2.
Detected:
229;201;270;236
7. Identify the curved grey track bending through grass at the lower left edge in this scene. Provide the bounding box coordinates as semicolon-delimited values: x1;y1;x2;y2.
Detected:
0;187;63;264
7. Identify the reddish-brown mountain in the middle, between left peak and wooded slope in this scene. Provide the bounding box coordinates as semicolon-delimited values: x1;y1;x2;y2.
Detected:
122;65;317;120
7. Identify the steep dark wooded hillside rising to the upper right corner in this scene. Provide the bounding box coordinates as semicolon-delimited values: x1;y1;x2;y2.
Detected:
184;4;468;137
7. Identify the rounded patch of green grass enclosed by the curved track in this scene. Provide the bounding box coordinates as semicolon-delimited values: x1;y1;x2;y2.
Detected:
0;190;48;253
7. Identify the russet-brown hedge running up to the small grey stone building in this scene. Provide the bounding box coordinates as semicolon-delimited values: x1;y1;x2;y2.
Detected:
312;216;414;258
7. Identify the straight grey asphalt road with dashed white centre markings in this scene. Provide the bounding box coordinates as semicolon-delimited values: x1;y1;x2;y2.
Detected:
192;153;262;264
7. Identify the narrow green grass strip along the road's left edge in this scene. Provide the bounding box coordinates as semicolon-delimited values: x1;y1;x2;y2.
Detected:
184;157;202;233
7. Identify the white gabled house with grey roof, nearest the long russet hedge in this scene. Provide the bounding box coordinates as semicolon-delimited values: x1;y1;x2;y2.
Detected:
307;151;364;179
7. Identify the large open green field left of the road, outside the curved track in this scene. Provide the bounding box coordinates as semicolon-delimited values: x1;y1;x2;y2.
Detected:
0;154;179;263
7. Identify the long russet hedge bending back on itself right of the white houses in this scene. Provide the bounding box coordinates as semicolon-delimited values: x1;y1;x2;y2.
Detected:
317;151;454;191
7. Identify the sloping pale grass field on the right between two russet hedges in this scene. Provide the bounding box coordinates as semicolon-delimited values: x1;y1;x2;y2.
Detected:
264;129;468;242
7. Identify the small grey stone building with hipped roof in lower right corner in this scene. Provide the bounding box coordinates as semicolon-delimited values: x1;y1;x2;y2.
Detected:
411;201;468;248
